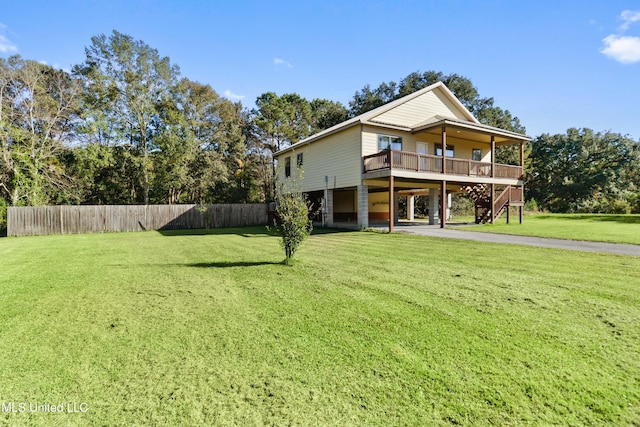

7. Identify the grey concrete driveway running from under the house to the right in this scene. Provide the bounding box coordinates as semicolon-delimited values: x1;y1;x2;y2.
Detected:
394;223;640;256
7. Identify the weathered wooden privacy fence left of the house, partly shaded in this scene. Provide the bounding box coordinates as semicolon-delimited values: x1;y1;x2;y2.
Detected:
7;204;268;236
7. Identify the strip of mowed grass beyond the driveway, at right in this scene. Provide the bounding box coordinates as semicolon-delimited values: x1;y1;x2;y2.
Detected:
466;214;640;245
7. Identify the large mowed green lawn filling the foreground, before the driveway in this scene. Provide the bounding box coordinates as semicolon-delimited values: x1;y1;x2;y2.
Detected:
0;228;640;426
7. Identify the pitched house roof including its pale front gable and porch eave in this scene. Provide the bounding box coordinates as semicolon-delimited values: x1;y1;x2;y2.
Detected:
274;82;530;157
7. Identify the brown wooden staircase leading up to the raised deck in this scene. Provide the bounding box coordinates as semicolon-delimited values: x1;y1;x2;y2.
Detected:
463;184;523;224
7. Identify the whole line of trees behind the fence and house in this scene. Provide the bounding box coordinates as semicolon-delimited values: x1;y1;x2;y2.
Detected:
0;31;640;231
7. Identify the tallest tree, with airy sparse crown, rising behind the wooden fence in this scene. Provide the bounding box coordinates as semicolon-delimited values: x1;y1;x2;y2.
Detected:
74;30;179;204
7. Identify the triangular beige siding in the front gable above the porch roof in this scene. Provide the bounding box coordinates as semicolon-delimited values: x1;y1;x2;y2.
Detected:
370;90;468;127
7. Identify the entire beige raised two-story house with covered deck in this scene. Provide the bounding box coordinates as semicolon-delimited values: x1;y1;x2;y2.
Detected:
275;82;530;231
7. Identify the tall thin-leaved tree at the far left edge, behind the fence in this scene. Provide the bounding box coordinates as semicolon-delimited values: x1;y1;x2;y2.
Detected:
0;56;79;205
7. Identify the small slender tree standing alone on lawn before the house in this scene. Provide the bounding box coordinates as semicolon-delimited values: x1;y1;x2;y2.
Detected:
276;168;313;265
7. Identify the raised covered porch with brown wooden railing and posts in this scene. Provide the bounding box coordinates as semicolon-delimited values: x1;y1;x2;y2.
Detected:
362;117;530;231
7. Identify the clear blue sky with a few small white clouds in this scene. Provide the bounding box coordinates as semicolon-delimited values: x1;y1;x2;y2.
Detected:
0;0;640;140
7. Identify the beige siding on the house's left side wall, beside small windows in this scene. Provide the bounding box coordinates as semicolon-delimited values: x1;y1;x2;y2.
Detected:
278;126;362;192
